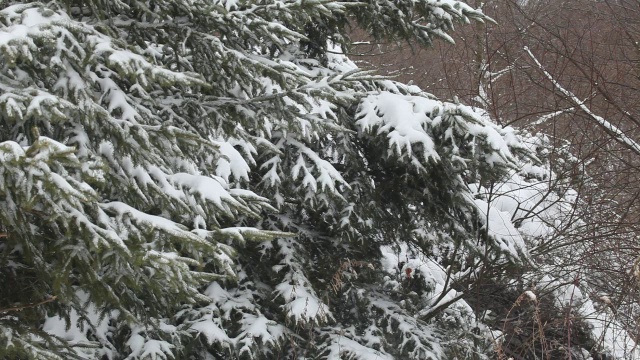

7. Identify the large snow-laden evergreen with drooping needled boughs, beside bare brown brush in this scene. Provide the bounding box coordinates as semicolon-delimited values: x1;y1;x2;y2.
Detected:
0;0;526;359
